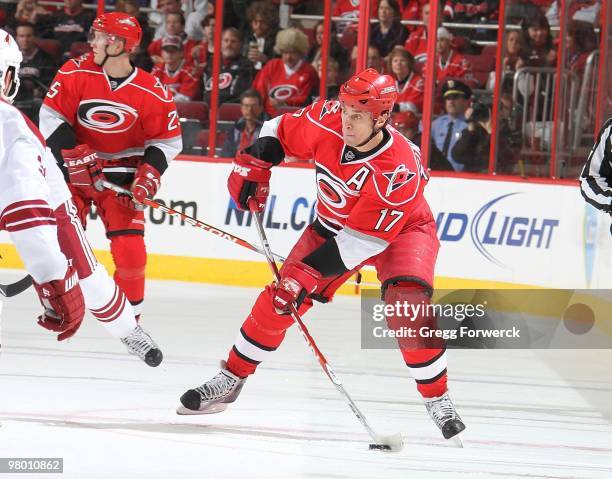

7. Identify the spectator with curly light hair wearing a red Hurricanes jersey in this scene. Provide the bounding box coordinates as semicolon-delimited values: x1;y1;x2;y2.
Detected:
253;28;319;116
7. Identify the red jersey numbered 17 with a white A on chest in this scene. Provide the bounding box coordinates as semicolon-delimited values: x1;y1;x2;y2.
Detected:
268;100;431;268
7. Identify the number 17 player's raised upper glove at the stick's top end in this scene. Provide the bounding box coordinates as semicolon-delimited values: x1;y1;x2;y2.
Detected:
227;153;272;212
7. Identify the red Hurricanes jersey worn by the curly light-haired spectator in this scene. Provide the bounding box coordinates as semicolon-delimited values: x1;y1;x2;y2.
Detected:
253;58;319;116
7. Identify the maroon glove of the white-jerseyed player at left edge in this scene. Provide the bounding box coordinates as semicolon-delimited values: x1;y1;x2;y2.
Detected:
34;266;85;341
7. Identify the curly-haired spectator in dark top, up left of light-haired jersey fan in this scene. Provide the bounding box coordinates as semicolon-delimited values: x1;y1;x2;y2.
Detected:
242;2;278;71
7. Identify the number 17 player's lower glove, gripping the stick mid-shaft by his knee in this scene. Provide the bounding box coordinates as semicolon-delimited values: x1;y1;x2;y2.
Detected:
272;262;321;314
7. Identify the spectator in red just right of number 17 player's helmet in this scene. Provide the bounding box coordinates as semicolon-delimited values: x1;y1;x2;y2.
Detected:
387;45;425;111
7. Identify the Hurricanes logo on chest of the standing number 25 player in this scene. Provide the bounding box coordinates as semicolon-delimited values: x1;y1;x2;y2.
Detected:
77;100;138;133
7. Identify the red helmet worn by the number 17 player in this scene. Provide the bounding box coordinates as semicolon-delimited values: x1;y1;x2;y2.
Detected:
338;68;397;118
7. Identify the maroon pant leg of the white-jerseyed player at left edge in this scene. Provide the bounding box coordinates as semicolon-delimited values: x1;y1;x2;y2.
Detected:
54;200;98;279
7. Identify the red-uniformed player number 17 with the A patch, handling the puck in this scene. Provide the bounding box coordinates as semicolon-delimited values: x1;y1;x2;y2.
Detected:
177;69;465;439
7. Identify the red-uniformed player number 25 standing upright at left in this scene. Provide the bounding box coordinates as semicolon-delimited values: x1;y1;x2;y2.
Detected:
40;13;182;315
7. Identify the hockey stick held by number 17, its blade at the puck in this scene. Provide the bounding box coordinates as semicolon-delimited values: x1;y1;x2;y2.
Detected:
249;200;404;452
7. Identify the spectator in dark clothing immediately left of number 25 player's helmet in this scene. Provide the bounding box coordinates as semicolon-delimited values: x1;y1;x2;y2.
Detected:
51;0;94;53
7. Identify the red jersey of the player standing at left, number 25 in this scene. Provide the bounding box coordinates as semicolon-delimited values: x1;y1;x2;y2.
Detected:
40;54;182;171
